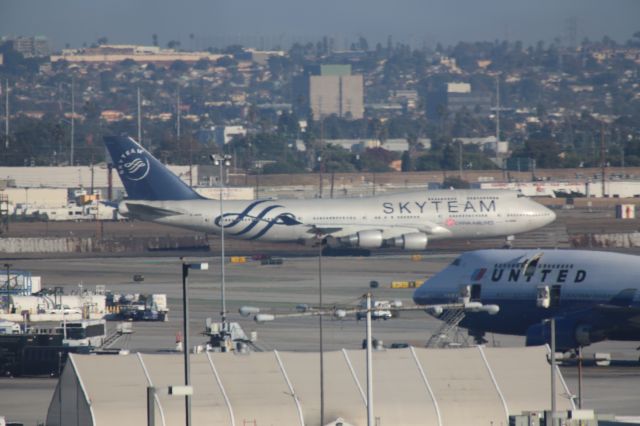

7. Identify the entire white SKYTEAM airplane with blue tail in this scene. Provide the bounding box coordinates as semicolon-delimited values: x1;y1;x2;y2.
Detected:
104;136;556;250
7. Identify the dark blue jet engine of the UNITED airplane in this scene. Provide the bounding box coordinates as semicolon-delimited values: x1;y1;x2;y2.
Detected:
527;317;605;351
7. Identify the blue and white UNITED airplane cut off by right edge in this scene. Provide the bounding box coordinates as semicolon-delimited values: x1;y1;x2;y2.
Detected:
413;249;640;352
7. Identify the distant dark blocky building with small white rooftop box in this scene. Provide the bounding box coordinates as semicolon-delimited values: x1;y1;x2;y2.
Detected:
426;83;492;119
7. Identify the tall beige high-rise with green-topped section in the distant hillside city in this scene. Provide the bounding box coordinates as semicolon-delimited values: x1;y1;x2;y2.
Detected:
293;65;364;120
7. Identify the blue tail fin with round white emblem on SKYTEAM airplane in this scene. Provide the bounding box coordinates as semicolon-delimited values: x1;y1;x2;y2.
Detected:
104;136;203;200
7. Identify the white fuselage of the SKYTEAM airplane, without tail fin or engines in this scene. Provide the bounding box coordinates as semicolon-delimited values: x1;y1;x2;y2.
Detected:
123;190;555;242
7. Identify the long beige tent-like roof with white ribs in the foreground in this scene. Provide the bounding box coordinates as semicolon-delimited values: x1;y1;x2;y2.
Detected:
47;346;573;426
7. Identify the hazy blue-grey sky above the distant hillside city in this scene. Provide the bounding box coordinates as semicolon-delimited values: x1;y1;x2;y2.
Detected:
0;0;640;48
